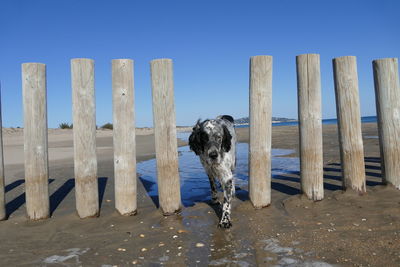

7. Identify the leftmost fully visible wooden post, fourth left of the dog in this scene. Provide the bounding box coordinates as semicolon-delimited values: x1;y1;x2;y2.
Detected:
22;63;50;220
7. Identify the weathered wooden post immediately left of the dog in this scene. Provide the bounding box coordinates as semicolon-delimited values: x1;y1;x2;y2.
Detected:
150;59;181;215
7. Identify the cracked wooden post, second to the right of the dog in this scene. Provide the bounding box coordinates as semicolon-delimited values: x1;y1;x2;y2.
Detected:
296;54;324;200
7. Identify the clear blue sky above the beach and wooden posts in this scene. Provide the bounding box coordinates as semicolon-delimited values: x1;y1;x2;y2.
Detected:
0;0;400;128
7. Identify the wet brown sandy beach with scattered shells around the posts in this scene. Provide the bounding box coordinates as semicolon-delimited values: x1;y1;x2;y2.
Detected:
0;123;400;266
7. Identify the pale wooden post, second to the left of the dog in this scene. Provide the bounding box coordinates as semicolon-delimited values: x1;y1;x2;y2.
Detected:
112;59;137;215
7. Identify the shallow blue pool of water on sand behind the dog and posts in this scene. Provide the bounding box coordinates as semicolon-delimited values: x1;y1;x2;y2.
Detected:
137;133;300;207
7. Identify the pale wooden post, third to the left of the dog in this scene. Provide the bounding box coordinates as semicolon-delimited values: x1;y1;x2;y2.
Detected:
71;58;99;218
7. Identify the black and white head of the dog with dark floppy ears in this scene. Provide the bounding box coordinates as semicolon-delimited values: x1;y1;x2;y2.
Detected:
189;119;232;164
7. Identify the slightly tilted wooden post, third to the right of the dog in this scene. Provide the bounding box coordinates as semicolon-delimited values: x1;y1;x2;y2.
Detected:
333;56;366;193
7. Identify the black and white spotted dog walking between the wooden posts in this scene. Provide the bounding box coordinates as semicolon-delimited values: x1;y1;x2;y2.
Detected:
189;115;236;228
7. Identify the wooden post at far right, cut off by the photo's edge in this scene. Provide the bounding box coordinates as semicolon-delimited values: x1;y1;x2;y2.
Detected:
372;58;400;189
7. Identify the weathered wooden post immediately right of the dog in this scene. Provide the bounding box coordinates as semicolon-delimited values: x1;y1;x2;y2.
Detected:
249;56;272;208
